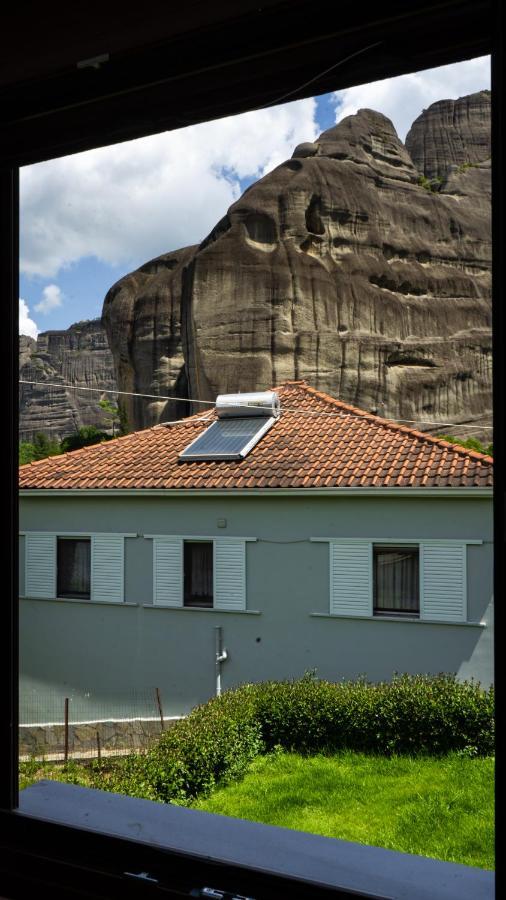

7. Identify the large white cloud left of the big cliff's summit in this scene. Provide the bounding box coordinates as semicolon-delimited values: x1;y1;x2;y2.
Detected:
21;99;318;278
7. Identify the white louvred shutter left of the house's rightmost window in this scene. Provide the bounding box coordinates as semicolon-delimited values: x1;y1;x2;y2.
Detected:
330;541;372;616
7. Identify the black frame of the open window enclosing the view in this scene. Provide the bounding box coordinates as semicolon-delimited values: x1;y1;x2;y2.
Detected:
0;0;506;898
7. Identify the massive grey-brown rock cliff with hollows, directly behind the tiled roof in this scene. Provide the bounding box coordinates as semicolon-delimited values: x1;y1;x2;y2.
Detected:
103;95;491;440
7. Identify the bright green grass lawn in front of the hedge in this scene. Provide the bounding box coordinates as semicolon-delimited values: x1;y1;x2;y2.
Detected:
194;752;494;869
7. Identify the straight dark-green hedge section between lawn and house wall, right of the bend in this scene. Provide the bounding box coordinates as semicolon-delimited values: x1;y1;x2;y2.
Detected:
249;675;494;755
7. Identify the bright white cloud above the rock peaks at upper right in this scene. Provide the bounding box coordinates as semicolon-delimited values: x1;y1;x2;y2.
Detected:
334;56;490;141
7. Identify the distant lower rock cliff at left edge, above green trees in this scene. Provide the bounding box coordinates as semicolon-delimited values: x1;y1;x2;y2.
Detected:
19;319;116;441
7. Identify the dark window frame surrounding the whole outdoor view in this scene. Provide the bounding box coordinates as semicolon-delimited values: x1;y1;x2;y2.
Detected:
0;2;506;898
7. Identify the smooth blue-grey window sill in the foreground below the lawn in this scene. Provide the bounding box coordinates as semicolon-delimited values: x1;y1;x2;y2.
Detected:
14;781;495;900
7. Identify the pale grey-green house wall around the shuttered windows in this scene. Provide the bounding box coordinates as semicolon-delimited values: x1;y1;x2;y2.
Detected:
20;495;493;721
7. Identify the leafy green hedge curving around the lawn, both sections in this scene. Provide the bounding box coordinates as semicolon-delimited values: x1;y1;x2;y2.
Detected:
96;675;494;803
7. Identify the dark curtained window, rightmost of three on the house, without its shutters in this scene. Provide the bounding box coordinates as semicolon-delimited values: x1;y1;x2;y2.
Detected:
373;546;420;618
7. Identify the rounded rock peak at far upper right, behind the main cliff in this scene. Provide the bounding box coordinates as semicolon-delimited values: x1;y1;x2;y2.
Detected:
406;91;492;178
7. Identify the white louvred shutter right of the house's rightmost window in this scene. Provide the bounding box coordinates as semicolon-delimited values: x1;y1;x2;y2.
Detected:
420;541;467;622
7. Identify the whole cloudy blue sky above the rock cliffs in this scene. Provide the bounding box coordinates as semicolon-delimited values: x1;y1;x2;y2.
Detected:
19;57;490;337
